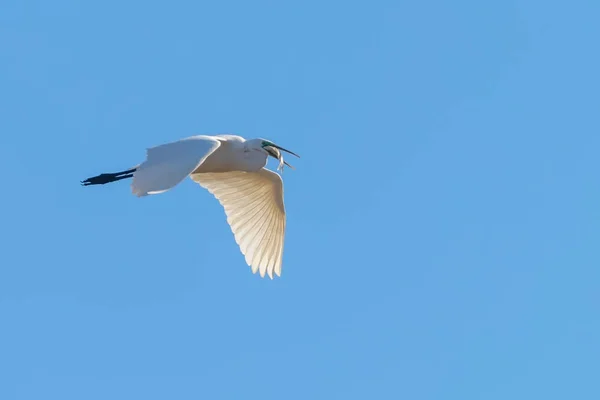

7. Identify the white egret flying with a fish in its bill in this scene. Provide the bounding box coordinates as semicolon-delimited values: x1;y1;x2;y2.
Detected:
81;135;300;279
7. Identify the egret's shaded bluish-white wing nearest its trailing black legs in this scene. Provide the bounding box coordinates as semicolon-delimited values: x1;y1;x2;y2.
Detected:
131;135;221;197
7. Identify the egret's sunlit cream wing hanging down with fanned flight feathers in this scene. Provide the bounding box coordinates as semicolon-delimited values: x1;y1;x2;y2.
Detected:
191;168;285;279
